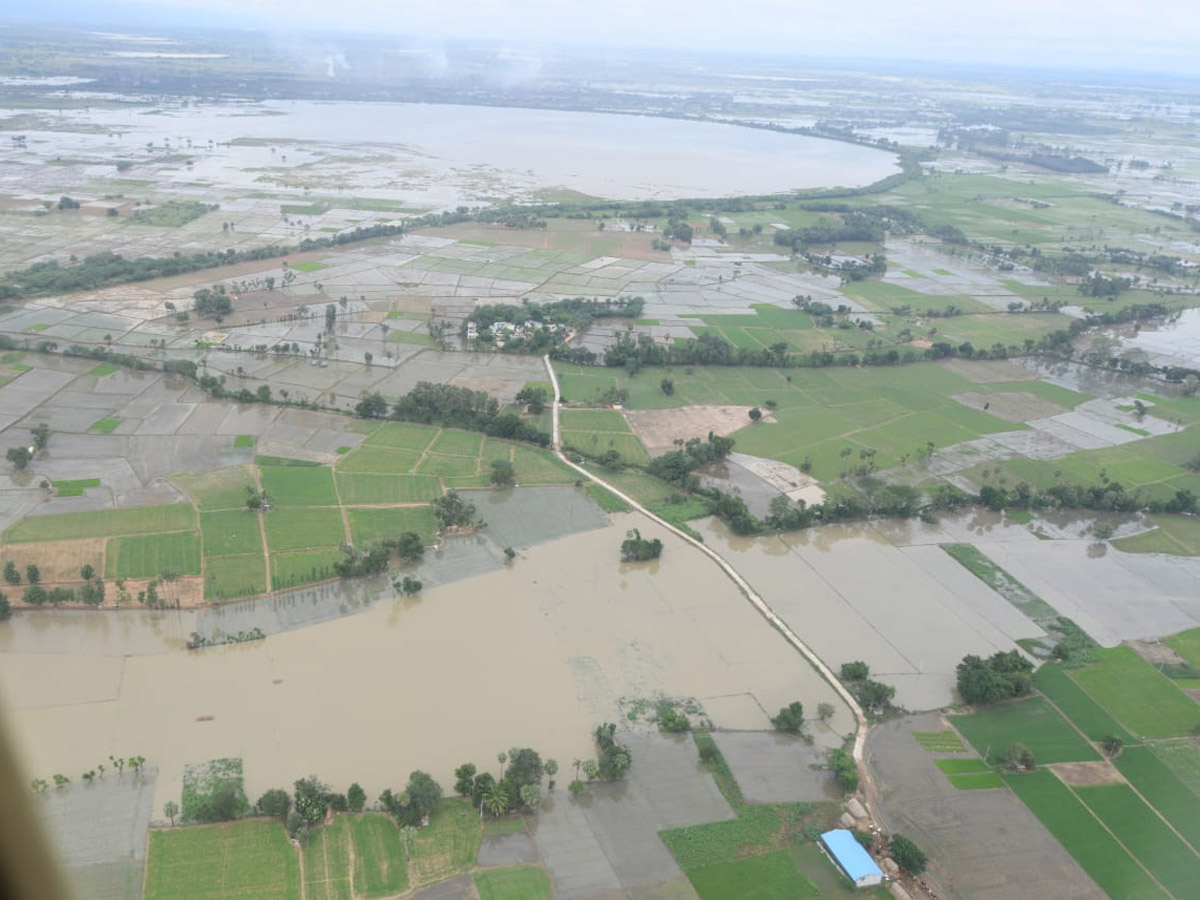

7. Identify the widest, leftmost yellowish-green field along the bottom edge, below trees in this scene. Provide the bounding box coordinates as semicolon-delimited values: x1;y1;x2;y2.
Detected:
145;820;300;900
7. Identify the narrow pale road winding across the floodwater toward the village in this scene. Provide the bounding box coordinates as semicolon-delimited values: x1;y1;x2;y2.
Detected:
542;355;875;805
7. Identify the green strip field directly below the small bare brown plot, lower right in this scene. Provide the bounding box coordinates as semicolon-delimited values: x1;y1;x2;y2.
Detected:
1075;785;1200;898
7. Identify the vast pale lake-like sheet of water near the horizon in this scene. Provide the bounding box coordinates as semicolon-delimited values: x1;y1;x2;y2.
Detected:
11;101;898;203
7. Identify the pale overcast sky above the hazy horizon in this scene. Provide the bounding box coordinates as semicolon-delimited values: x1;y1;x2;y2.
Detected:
21;0;1200;72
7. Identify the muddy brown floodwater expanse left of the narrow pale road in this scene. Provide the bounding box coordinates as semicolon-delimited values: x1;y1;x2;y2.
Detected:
0;514;853;810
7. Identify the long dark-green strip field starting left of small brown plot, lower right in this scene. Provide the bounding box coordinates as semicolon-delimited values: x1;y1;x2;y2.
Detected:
1004;769;1169;900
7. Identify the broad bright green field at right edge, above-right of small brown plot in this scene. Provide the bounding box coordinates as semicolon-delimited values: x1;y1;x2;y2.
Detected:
1070;647;1200;738
